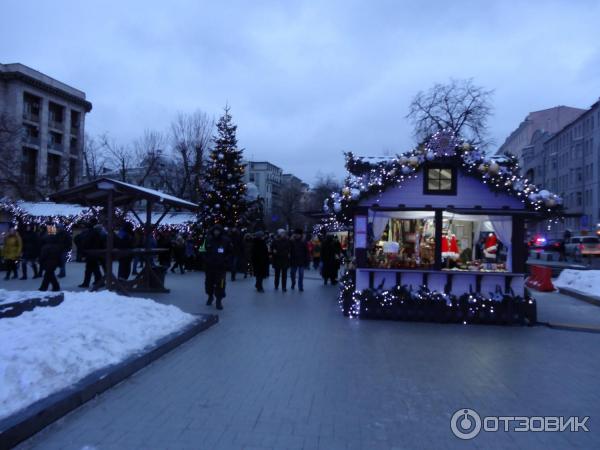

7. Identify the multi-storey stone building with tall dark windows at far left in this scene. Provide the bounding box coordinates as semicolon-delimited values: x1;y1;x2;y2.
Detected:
0;64;92;197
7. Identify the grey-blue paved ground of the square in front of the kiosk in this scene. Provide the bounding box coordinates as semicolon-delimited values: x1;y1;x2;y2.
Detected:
2;264;600;450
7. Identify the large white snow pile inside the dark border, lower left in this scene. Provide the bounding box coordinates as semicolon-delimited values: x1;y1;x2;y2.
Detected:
0;292;194;419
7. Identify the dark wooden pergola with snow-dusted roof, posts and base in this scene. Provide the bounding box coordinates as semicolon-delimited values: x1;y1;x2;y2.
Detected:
49;178;199;293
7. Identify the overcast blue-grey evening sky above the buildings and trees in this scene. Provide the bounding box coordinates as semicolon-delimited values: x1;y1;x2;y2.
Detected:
0;0;600;182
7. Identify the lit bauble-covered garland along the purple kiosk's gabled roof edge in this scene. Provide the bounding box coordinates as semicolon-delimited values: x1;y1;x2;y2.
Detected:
323;130;563;229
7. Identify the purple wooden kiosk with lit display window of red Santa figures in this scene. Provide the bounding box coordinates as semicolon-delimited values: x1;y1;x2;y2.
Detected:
354;158;538;295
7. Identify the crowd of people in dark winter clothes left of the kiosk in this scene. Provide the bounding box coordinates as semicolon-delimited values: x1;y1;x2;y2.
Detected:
2;220;345;309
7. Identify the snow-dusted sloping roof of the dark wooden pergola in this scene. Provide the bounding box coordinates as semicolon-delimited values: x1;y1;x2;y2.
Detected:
49;178;198;210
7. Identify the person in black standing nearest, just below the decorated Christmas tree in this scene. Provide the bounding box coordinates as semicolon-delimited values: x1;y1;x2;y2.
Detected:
204;225;231;309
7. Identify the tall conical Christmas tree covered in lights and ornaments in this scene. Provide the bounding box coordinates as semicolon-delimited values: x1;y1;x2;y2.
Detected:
200;106;246;230
